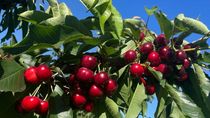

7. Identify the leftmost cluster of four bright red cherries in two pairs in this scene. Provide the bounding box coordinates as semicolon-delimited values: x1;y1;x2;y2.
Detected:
16;64;52;115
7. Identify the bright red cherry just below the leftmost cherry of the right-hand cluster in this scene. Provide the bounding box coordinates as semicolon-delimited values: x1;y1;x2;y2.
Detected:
130;63;144;77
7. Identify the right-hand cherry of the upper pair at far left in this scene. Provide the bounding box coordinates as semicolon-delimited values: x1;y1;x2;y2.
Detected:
36;64;52;81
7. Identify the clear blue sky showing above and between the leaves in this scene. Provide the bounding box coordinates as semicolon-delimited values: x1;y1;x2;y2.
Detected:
0;0;210;118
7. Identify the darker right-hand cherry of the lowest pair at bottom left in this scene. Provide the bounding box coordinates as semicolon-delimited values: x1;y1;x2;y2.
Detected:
36;100;49;115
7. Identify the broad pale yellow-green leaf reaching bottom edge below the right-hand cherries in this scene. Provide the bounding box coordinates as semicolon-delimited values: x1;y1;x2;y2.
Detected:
126;84;147;118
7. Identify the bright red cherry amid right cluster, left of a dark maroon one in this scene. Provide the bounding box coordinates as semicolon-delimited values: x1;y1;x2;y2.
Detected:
147;51;161;66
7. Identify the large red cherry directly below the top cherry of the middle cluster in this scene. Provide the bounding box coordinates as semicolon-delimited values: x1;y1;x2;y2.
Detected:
76;67;94;83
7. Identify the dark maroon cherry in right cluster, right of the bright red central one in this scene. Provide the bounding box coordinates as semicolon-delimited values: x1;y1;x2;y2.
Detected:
158;46;174;61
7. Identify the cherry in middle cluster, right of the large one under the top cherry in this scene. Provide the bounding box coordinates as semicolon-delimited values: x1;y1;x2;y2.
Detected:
94;72;109;86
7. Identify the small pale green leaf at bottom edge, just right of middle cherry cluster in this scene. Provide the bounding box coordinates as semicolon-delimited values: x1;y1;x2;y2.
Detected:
105;97;121;118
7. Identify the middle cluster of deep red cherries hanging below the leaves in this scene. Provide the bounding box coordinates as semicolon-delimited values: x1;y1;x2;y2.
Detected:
69;55;118;112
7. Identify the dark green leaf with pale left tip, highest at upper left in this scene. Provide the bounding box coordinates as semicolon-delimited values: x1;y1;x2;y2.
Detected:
19;10;52;24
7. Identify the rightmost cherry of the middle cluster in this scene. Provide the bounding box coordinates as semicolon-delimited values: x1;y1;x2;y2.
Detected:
105;79;118;96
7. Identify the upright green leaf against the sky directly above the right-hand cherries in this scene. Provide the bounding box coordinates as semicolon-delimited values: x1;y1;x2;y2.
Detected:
154;12;174;39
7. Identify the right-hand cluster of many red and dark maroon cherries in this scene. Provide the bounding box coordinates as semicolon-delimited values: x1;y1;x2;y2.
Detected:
124;33;196;95
